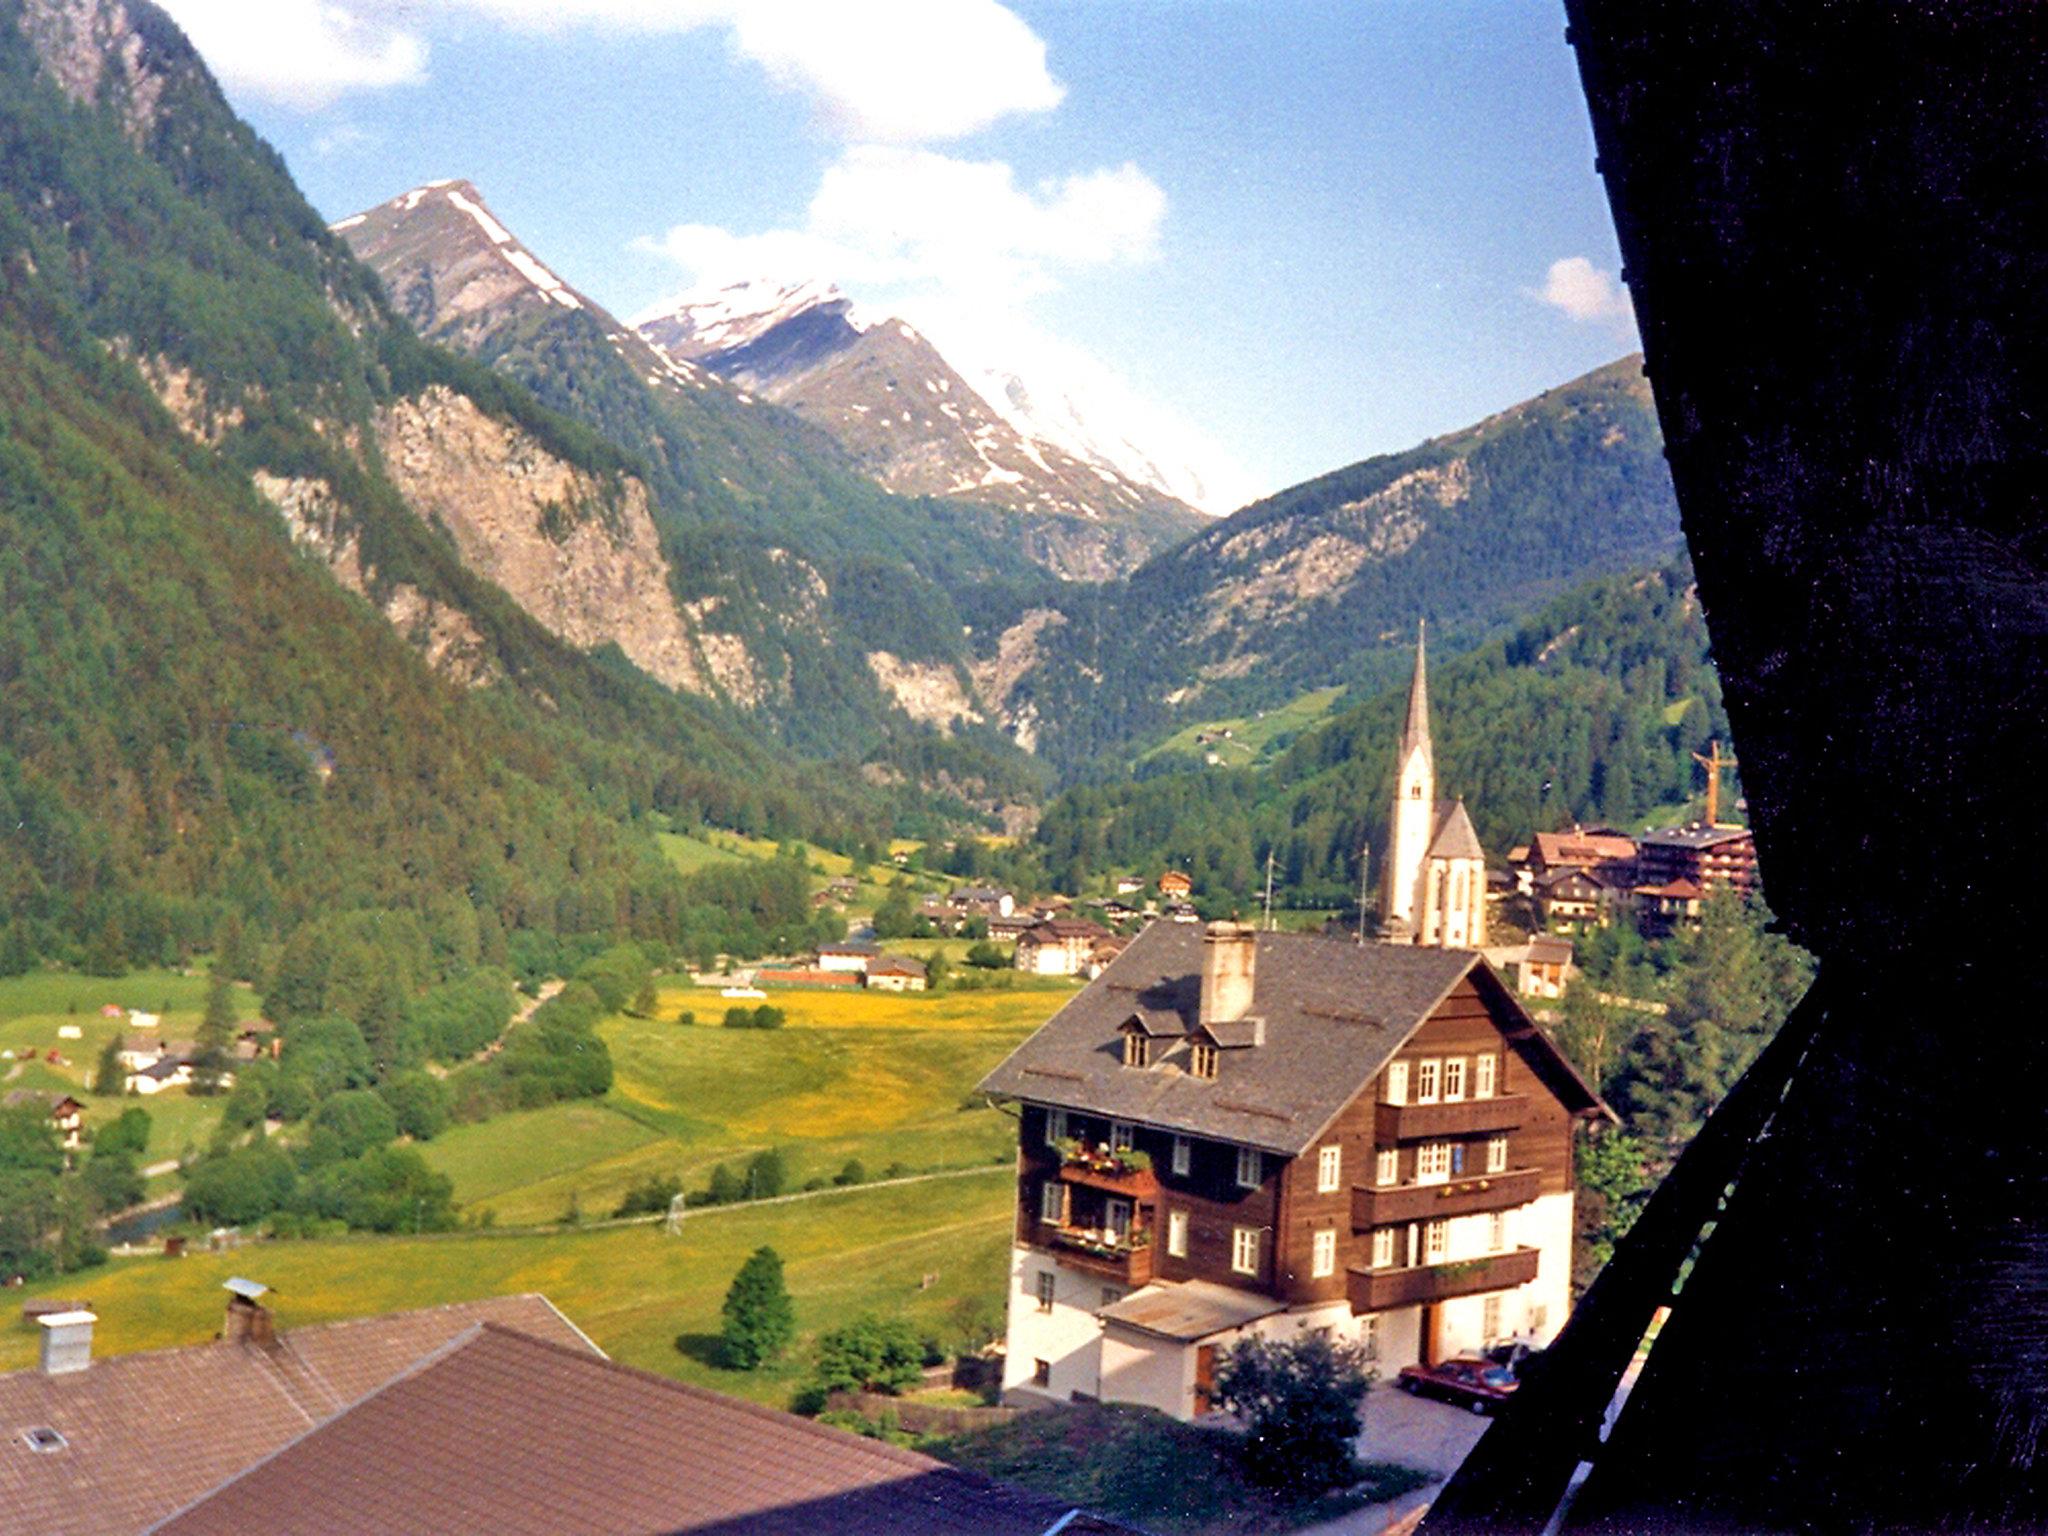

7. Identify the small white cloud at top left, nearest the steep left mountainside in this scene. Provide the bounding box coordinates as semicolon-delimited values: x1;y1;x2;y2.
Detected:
164;0;426;113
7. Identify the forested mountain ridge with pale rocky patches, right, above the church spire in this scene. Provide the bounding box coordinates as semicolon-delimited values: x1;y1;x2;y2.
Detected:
969;358;1679;770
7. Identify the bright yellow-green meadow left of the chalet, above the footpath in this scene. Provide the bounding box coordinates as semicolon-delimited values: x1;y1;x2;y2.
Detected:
424;985;1069;1225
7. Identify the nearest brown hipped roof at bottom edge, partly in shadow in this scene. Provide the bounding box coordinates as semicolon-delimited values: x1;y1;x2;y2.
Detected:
154;1323;1135;1536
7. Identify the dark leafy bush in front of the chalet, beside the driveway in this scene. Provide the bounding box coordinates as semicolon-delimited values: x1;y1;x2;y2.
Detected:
1217;1329;1372;1493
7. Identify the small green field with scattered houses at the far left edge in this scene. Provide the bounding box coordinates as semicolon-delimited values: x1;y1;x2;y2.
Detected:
0;971;260;1161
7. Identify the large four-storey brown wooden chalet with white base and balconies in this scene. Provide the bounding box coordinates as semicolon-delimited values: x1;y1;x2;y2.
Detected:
981;924;1612;1419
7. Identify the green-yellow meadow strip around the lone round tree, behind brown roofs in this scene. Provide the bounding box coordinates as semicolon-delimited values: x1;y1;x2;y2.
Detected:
0;1167;1016;1405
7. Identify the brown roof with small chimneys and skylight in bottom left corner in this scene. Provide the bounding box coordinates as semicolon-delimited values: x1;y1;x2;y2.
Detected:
0;1296;596;1536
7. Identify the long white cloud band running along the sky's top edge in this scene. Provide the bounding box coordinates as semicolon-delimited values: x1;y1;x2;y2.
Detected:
168;0;1065;143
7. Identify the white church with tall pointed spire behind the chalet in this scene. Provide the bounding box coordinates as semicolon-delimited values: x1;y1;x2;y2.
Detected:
1380;631;1487;950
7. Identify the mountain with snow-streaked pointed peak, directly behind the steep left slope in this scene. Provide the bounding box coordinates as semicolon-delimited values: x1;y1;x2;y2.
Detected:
334;180;1059;770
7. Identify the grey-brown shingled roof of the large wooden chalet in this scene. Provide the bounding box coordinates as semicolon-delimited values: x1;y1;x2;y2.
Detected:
981;924;1599;1157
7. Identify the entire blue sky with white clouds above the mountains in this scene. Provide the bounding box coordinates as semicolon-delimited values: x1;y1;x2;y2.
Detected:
168;0;1636;506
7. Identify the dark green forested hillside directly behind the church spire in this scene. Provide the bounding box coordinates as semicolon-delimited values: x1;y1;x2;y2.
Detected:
1036;565;1726;911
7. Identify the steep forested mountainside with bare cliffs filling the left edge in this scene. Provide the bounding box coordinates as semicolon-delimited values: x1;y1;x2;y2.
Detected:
0;0;965;967
